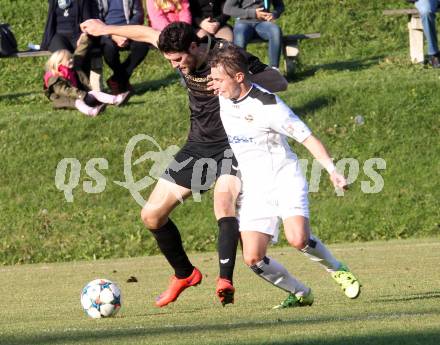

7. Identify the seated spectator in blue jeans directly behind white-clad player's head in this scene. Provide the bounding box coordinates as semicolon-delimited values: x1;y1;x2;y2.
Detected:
223;0;284;69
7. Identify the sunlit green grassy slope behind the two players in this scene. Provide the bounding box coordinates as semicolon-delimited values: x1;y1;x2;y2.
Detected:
0;0;440;264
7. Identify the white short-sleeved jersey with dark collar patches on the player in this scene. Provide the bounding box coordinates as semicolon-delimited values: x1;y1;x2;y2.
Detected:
219;84;311;235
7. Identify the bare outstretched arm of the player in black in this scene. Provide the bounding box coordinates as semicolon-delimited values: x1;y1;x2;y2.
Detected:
81;19;160;46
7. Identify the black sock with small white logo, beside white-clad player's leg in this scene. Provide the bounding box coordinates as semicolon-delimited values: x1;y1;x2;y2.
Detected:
217;217;240;282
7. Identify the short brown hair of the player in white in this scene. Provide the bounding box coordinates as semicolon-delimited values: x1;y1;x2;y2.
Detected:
209;44;249;77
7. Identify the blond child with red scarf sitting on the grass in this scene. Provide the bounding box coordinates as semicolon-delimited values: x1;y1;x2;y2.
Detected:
44;34;128;116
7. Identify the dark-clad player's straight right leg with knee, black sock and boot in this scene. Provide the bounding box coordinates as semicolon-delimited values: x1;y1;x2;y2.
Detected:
214;175;241;306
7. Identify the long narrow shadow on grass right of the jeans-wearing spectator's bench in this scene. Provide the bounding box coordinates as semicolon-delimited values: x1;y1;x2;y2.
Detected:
289;55;385;81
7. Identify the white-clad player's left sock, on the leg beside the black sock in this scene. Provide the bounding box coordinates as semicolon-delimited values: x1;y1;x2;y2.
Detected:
249;256;310;297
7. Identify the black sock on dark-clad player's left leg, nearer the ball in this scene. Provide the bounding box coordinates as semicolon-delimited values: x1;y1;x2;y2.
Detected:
150;219;194;279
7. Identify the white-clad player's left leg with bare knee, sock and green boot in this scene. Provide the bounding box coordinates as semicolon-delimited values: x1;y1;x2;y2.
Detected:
241;231;313;308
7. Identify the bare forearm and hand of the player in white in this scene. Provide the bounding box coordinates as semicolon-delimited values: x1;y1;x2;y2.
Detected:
302;134;348;189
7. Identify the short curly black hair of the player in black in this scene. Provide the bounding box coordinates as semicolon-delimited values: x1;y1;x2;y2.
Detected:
158;22;199;53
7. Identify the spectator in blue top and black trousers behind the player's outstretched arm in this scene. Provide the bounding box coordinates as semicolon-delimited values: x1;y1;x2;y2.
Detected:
97;0;149;95
